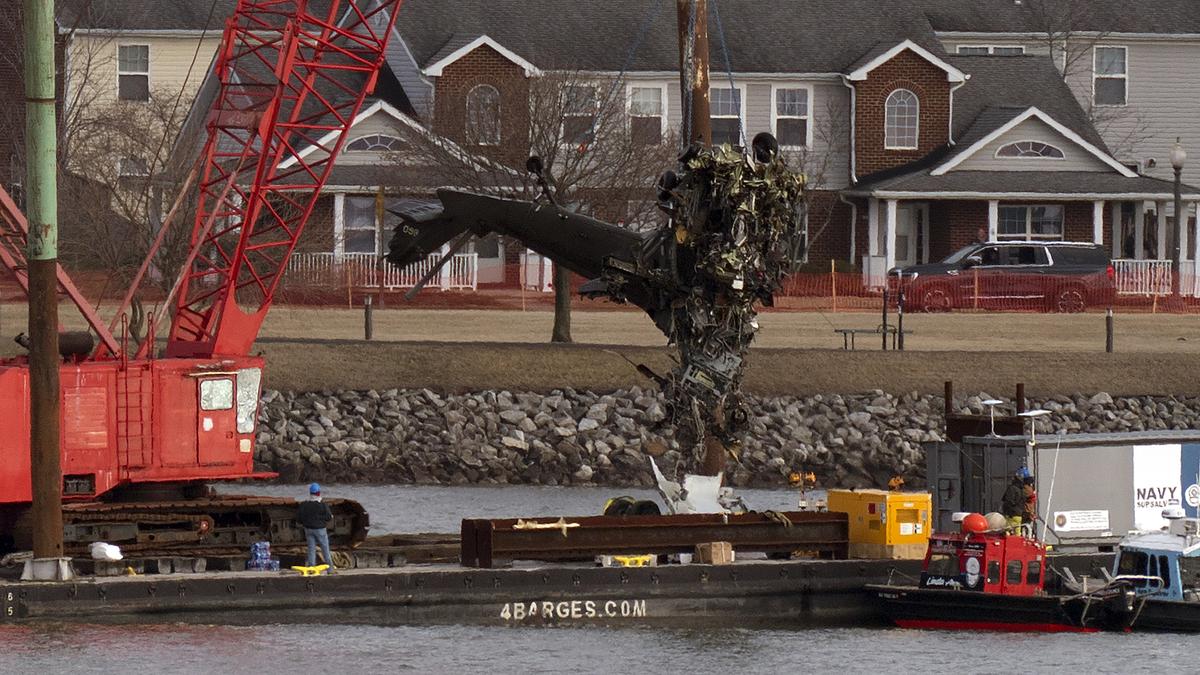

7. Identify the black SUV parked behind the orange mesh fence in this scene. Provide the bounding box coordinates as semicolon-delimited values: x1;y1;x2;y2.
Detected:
889;241;1116;312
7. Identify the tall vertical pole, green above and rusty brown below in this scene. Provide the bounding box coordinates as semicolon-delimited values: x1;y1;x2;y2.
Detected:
24;0;62;558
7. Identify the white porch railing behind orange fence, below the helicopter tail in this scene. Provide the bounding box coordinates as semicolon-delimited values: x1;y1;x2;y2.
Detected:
287;248;479;291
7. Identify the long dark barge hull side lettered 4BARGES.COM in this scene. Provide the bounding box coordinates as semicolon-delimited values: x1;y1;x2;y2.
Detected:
0;555;1111;628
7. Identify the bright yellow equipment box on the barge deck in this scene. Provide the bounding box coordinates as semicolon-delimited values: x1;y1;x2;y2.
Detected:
828;490;932;558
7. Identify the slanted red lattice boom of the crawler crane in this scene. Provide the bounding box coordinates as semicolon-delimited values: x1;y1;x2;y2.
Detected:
167;0;401;357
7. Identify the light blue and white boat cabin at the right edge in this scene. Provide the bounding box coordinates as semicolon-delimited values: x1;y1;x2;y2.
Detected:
1112;512;1200;602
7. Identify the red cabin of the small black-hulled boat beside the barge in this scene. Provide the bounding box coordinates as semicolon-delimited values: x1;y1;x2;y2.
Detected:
920;532;1045;596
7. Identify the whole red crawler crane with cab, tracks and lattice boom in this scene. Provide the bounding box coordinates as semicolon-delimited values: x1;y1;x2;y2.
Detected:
0;0;401;550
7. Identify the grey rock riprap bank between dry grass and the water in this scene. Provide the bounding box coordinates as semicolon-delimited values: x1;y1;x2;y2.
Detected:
254;387;1200;488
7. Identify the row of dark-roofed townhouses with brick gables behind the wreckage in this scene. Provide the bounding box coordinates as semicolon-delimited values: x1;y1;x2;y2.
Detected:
159;0;1200;289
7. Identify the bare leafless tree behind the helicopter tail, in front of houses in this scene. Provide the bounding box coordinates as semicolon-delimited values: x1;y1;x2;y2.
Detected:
408;71;677;342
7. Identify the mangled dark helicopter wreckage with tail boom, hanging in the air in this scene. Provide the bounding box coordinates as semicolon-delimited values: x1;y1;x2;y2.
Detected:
388;133;806;499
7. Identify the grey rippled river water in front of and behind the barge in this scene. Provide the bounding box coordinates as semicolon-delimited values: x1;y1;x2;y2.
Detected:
0;485;1200;675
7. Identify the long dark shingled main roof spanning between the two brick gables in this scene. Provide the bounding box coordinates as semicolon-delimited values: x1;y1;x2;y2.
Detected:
396;0;942;78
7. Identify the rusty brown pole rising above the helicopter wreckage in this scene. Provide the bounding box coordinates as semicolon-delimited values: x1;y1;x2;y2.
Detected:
676;0;713;148
